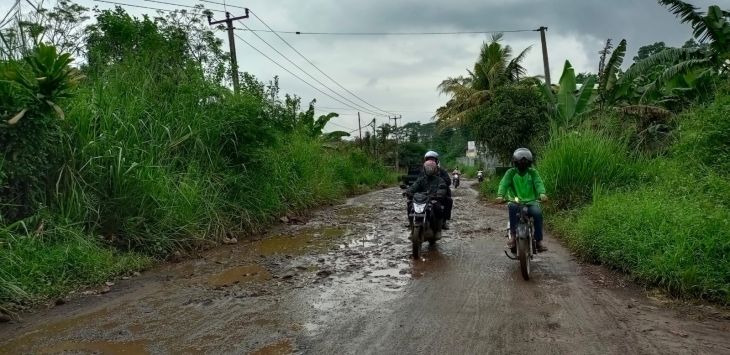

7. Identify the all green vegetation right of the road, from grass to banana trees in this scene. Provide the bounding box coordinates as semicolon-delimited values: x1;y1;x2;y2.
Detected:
438;0;730;304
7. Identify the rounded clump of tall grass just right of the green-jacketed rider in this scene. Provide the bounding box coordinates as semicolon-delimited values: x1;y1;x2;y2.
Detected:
537;130;640;208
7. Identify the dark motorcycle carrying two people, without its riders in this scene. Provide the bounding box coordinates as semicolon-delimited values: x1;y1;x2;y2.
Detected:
408;193;443;259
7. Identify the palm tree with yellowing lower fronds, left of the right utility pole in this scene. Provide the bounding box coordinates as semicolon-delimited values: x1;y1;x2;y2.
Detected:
436;33;537;126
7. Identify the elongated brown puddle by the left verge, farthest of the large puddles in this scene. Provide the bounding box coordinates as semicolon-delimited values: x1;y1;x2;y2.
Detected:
253;228;346;256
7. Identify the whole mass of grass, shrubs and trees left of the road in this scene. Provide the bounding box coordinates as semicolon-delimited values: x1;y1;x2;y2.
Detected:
0;3;395;310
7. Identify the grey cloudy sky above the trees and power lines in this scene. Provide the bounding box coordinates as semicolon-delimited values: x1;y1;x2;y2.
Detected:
0;0;716;134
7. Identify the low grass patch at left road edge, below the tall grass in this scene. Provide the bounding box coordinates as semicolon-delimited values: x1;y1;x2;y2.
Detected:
0;222;153;309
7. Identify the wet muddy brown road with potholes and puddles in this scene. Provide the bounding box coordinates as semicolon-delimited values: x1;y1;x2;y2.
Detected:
0;183;730;354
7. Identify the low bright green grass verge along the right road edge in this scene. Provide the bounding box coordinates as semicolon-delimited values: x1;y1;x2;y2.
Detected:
553;165;730;304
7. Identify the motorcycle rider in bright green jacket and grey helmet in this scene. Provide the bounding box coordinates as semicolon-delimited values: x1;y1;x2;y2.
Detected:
497;148;547;252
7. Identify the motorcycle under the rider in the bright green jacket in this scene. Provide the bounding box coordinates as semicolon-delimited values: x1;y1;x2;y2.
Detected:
504;198;538;281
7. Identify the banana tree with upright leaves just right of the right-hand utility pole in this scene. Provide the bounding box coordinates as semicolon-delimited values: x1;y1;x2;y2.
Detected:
542;60;595;128
